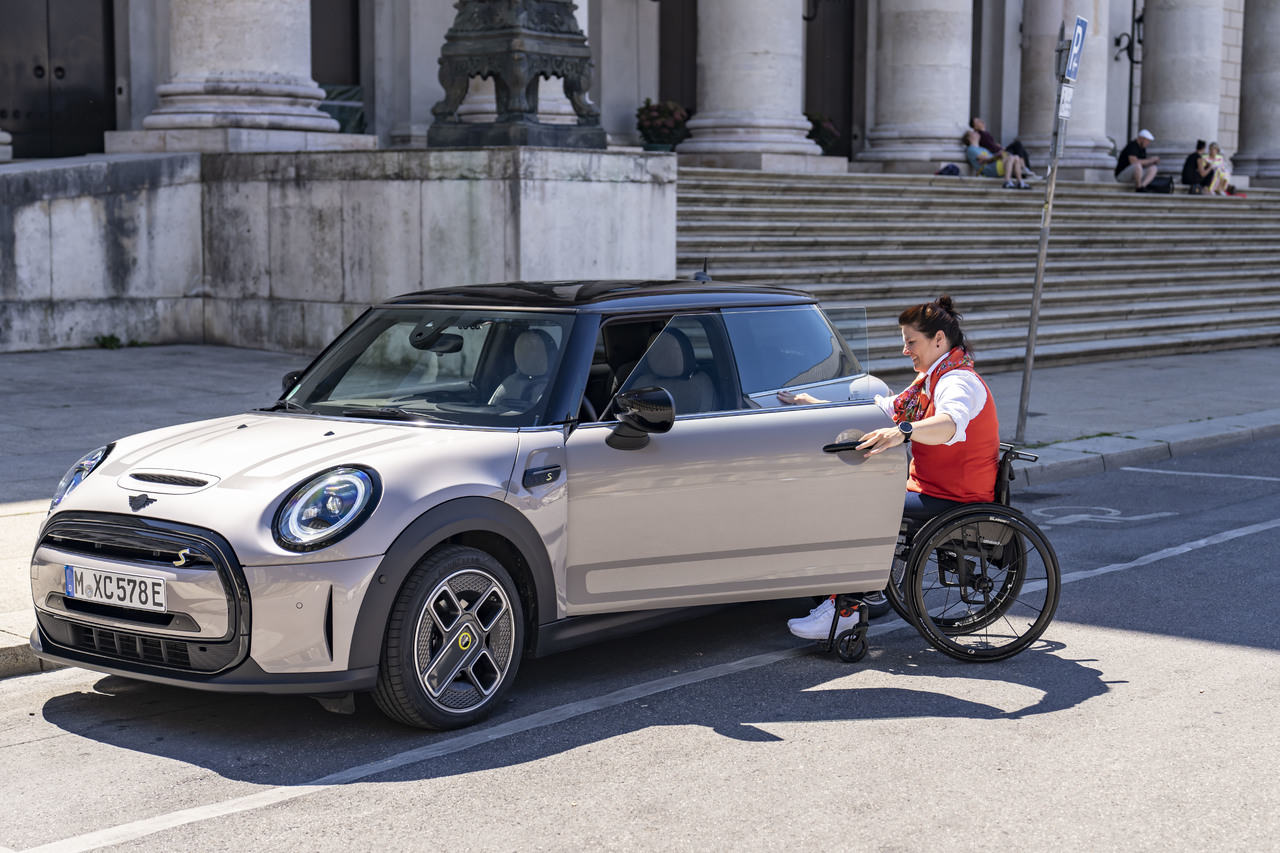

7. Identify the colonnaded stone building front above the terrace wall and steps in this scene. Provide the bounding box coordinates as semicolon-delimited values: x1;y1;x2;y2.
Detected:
0;0;1280;183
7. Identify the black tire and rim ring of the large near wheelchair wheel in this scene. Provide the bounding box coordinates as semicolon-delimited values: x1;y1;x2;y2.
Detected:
906;503;1062;663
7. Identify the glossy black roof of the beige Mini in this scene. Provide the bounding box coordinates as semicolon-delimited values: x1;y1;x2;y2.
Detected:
383;279;817;313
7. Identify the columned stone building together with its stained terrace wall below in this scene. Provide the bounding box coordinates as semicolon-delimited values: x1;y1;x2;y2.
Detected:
0;0;1280;352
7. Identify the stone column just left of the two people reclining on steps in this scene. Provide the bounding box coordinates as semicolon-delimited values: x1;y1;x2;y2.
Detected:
855;0;973;173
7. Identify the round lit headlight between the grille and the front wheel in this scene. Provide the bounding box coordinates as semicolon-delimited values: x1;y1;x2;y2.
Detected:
271;467;381;551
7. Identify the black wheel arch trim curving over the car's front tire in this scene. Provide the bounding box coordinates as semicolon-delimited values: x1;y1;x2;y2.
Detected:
348;497;556;669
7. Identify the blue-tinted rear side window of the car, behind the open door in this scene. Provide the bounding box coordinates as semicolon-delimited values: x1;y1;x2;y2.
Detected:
721;305;863;406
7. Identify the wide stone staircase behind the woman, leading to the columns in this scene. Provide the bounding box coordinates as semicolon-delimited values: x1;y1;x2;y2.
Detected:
676;168;1280;379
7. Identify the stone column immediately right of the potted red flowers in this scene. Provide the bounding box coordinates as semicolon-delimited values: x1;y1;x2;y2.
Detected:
678;0;824;170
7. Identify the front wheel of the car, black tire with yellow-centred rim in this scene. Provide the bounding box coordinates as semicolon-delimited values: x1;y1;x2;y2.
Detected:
374;546;525;729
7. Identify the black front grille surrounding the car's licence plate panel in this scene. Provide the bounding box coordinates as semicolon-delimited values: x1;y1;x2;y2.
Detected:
37;512;250;675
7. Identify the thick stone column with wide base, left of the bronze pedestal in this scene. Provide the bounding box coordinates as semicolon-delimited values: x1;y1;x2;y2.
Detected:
108;0;372;152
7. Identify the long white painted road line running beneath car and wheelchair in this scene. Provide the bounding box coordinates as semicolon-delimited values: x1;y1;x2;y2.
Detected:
24;519;1280;853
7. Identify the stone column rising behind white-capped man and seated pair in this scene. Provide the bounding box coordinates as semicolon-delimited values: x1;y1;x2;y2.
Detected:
1136;0;1223;158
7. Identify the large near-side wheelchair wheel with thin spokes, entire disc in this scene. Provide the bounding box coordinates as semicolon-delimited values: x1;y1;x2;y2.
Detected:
906;505;1061;661
